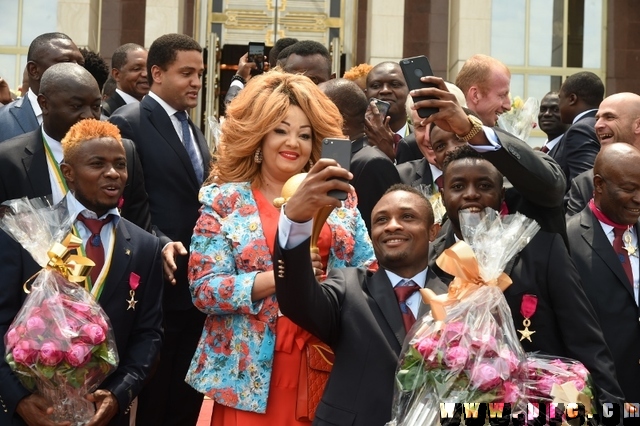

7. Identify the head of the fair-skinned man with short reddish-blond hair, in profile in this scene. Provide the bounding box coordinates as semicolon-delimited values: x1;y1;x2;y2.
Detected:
456;54;511;127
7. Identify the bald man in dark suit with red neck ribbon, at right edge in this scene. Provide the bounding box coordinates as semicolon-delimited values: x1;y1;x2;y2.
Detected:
567;143;640;408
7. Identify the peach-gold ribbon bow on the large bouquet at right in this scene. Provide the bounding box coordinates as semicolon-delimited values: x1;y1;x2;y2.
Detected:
420;241;512;321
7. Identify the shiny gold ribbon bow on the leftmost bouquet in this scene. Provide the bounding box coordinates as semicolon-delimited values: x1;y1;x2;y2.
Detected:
22;233;96;293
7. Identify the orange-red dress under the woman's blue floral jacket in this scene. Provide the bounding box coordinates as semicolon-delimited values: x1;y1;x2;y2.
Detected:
211;189;331;426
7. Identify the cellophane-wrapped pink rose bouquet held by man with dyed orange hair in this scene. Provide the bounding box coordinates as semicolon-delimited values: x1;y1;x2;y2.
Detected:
0;198;118;425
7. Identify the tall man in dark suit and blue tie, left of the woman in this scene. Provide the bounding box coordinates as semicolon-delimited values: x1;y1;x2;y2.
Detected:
109;34;211;426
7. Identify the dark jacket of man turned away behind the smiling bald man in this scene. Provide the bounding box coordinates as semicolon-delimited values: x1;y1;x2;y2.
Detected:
549;111;600;196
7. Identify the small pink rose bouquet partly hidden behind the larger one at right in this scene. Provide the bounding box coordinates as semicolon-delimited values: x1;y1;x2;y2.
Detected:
523;353;596;414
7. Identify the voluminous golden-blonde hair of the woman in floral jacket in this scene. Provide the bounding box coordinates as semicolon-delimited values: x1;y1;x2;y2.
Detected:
214;70;343;185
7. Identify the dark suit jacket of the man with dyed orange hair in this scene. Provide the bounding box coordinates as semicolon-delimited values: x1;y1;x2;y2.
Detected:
0;219;162;426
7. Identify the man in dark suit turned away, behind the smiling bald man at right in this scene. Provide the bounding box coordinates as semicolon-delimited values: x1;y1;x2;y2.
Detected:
549;71;604;195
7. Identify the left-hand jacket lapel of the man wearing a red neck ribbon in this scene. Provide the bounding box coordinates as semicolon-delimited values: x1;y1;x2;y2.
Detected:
580;209;635;303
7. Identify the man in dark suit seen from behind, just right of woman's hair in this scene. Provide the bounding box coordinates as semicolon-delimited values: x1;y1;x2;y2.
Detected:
318;78;400;235
